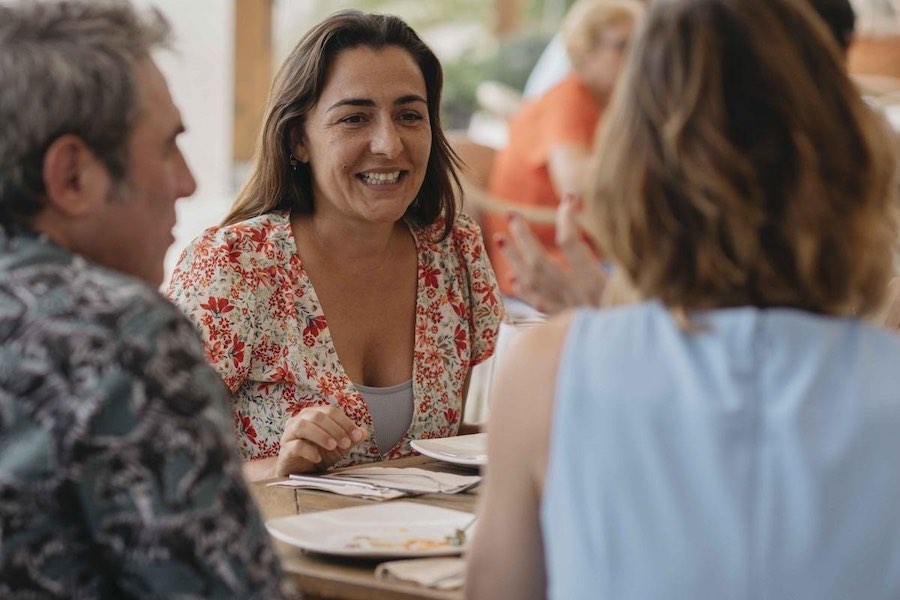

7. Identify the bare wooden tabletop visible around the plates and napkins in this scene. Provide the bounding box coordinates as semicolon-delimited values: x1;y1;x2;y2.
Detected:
251;456;478;600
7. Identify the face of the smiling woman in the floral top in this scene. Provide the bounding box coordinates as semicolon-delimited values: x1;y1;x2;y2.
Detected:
294;46;432;223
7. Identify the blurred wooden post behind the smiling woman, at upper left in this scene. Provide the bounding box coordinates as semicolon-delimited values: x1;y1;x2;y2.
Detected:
232;0;272;161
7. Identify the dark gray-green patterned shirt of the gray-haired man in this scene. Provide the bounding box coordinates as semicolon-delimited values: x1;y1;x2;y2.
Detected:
0;228;283;598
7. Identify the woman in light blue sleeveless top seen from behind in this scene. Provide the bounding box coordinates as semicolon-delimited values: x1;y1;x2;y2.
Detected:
467;0;900;600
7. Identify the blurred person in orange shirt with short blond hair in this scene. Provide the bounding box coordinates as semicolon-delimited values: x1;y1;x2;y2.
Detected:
484;0;643;295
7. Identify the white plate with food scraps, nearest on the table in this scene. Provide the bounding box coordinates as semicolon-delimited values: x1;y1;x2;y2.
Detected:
266;502;475;558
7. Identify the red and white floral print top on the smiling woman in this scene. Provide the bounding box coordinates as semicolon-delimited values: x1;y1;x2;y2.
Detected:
168;213;503;466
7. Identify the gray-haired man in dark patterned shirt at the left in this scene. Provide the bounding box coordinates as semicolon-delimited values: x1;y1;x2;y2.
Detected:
0;0;282;598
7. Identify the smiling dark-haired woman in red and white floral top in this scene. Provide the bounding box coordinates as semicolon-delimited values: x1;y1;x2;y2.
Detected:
169;11;502;478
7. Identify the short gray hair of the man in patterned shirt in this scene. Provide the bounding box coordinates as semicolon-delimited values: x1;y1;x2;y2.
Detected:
0;0;170;224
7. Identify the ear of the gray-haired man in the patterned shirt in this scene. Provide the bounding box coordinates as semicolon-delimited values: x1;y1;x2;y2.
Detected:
43;134;112;218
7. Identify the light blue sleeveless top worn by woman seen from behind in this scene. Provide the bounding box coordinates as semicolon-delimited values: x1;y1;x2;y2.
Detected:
541;303;900;600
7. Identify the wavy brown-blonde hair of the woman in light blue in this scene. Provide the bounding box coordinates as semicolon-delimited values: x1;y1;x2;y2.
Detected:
588;0;898;316
